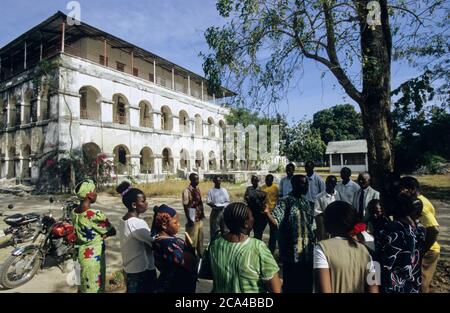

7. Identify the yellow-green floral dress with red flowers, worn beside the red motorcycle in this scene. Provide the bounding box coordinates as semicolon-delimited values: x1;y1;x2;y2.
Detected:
72;209;112;293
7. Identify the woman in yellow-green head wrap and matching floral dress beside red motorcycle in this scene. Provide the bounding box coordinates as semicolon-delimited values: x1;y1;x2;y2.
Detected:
72;179;116;293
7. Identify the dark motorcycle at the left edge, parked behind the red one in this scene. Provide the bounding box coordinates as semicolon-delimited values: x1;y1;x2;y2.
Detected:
0;204;39;247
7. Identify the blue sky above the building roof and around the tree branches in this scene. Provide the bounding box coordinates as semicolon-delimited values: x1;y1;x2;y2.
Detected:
0;0;417;122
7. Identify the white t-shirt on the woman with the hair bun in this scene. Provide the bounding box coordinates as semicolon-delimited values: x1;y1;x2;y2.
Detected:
119;217;155;274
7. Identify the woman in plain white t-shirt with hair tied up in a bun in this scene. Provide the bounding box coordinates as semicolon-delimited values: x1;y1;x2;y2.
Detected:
116;182;157;293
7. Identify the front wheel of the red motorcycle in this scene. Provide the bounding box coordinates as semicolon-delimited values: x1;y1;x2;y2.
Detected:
0;246;43;289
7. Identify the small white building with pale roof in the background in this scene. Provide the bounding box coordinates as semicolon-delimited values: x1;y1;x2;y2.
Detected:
326;140;369;173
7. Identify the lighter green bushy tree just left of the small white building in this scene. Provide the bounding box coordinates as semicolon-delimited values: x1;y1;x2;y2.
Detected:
284;121;326;162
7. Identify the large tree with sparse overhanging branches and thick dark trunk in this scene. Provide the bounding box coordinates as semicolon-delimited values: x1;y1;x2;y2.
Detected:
203;0;448;185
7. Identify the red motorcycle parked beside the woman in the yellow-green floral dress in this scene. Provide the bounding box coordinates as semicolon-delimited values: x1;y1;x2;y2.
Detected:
0;197;77;289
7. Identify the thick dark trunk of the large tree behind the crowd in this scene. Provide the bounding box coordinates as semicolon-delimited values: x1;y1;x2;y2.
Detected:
358;0;394;190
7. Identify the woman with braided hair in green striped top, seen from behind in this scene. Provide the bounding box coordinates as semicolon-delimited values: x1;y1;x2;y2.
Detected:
205;202;281;293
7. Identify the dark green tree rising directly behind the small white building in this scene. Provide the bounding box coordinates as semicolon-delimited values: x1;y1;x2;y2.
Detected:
312;104;363;144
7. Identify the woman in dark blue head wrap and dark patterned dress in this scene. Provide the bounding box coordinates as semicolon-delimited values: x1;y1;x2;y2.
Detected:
152;205;197;293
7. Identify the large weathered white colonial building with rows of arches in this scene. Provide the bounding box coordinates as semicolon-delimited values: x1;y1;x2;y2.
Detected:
0;12;234;182
